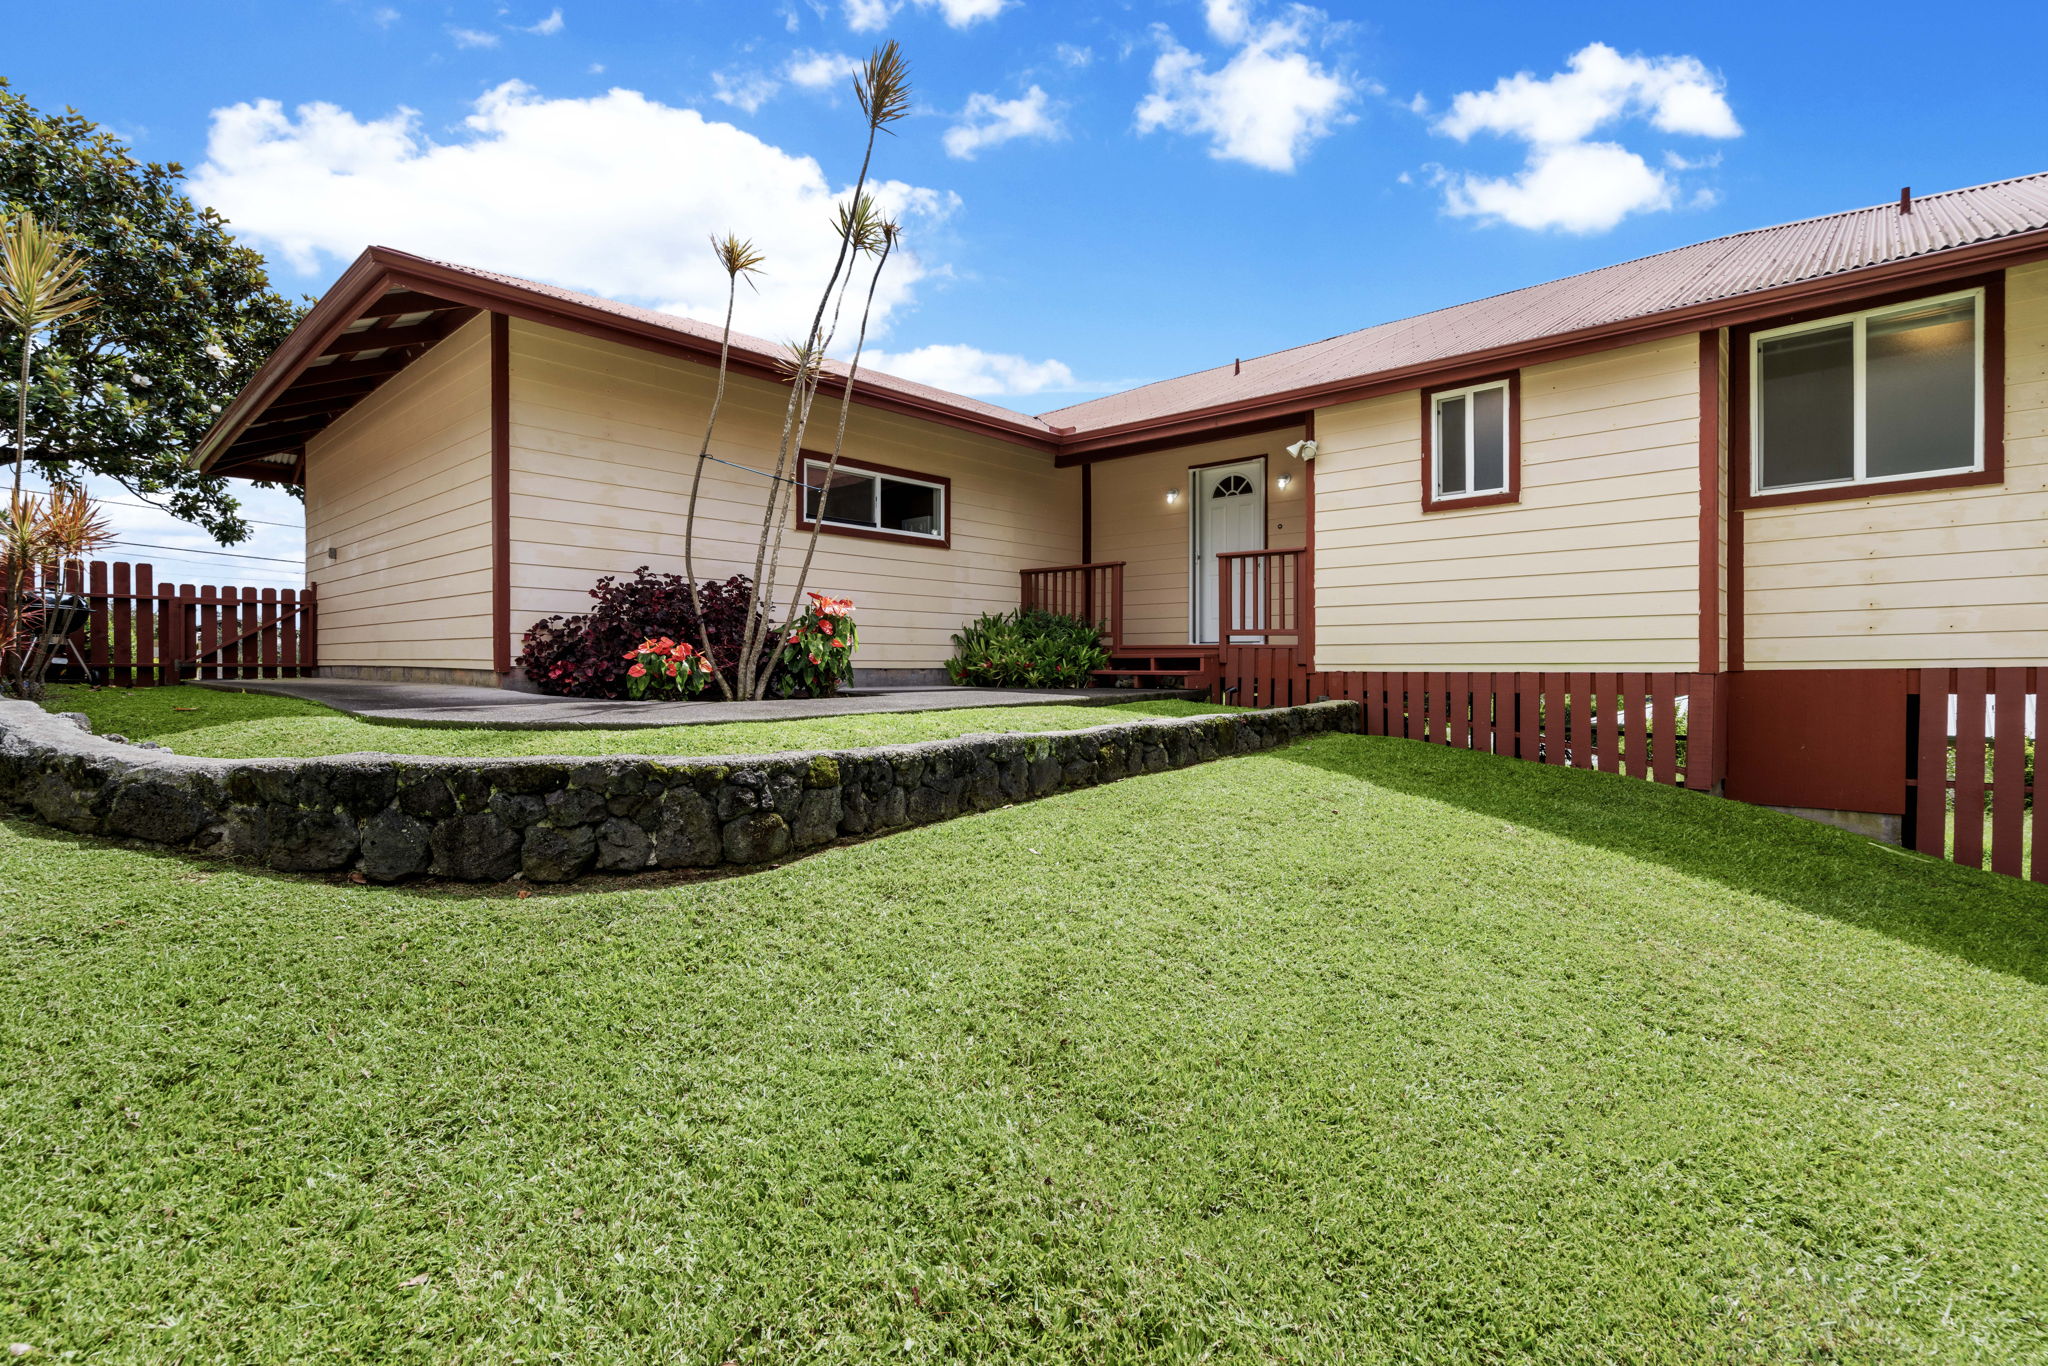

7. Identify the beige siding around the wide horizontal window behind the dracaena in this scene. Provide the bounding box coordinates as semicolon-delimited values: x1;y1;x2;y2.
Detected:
510;319;1081;668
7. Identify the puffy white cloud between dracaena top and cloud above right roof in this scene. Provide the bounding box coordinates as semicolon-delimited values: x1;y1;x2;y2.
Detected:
1137;0;1358;170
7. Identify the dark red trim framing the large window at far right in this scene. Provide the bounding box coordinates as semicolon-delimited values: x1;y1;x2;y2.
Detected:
1729;270;2005;508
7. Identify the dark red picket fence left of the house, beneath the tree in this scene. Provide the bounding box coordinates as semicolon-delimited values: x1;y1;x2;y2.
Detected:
24;559;317;688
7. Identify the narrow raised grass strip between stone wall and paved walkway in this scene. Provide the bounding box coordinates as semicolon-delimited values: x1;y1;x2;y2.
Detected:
43;684;1239;760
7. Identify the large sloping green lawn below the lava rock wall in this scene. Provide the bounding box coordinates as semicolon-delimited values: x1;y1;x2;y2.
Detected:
12;735;2048;1366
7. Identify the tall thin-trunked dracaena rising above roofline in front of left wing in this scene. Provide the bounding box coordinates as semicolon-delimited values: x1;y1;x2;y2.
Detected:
682;43;909;698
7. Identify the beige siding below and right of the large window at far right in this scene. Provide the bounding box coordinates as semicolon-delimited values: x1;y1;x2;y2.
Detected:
1743;262;2048;670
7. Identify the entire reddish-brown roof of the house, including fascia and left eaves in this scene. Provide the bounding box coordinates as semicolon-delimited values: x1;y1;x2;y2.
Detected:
195;172;2048;475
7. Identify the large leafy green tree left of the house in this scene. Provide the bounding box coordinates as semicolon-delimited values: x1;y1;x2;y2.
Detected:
0;80;301;545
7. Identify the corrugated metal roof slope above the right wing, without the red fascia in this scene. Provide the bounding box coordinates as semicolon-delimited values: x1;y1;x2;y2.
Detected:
1040;172;2048;436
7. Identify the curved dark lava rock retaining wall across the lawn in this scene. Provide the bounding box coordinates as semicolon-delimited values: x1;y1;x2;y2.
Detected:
0;702;1358;883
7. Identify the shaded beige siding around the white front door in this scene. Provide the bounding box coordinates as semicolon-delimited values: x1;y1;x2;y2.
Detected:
1094;428;1307;645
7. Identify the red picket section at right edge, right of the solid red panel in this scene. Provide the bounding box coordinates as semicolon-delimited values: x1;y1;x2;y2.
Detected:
1905;668;2048;883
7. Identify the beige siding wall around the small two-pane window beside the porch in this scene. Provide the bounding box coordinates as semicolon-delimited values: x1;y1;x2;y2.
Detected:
1315;336;1700;670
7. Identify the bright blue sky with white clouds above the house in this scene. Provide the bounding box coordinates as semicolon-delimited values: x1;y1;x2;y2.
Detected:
4;0;2048;581
